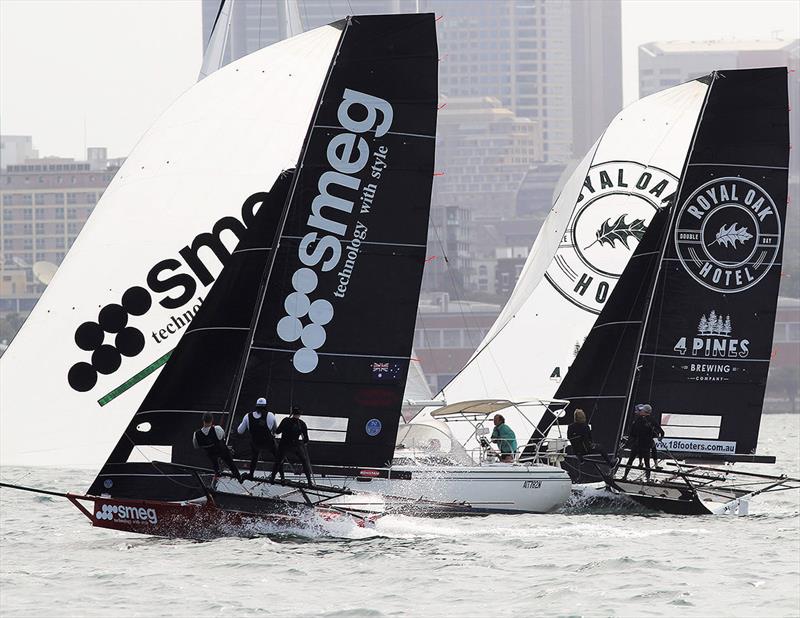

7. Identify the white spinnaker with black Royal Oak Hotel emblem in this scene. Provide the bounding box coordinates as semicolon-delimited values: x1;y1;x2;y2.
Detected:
418;81;707;448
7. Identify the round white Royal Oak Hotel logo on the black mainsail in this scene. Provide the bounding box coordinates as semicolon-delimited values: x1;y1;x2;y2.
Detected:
675;178;781;293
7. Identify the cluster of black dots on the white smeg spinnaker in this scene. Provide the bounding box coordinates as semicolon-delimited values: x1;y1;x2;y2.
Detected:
67;286;153;393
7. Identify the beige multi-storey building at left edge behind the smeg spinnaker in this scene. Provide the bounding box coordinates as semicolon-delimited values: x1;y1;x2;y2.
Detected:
0;143;117;313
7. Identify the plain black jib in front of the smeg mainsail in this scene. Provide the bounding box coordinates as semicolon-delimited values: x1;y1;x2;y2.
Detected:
89;172;294;500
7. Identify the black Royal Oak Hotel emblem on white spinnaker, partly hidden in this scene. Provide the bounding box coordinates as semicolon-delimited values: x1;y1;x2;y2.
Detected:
545;161;678;314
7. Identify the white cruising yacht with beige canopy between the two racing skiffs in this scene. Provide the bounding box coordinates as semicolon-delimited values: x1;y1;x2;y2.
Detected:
242;399;571;515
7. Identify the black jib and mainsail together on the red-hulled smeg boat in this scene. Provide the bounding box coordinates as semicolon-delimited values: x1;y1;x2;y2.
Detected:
90;15;438;499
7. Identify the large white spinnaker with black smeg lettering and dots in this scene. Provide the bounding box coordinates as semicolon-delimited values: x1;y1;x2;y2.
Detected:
0;26;341;466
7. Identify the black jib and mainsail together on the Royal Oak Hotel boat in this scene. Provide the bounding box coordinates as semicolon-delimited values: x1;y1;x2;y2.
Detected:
540;68;789;472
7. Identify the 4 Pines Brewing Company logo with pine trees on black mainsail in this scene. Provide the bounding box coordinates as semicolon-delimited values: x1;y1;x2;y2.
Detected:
673;309;750;382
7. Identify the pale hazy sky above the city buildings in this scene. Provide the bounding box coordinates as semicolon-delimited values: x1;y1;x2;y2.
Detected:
0;0;800;158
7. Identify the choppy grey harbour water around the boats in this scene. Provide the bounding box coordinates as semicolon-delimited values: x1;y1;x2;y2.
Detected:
0;415;800;618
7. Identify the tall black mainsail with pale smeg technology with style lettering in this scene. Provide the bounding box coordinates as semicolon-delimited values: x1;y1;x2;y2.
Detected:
234;14;438;466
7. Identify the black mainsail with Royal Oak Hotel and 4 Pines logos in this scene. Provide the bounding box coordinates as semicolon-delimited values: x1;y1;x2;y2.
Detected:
631;68;789;455
